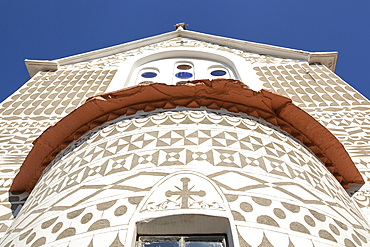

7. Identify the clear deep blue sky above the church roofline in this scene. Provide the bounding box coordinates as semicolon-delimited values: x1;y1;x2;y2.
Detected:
0;0;370;101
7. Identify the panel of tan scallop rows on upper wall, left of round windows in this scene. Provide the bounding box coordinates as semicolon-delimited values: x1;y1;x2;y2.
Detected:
0;69;116;117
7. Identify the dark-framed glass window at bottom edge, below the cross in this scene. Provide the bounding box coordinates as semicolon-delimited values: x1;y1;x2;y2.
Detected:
137;235;226;247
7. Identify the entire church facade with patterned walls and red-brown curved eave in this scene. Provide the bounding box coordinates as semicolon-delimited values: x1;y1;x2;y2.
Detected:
0;25;370;247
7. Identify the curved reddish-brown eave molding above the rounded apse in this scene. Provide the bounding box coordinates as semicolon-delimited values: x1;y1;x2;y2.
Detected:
10;79;364;192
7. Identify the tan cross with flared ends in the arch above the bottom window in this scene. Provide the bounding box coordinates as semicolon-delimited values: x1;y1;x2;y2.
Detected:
166;177;206;209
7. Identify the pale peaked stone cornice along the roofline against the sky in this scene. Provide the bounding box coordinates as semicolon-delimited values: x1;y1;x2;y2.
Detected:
25;28;338;77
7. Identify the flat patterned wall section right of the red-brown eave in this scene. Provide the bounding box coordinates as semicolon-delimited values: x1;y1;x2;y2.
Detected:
254;64;370;222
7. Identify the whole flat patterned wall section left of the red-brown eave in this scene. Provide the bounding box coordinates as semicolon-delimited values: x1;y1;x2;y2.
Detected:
0;69;116;237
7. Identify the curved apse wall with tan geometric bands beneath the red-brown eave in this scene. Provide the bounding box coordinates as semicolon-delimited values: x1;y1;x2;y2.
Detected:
2;111;370;246
